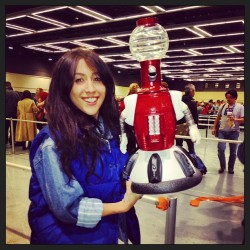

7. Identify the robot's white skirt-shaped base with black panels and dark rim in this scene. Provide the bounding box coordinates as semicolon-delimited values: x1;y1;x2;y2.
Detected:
123;146;202;194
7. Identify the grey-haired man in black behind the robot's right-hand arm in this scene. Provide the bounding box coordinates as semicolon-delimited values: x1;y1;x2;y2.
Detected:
175;83;198;154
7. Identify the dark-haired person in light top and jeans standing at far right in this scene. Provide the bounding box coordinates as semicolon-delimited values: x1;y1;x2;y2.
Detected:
212;89;244;174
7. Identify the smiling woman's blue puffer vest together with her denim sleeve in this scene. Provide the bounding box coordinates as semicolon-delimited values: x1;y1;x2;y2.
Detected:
28;126;140;244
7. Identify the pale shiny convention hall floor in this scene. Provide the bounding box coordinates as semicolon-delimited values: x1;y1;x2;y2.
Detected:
6;129;244;244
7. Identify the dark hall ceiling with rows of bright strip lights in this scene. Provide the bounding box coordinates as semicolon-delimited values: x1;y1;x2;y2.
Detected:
5;5;245;82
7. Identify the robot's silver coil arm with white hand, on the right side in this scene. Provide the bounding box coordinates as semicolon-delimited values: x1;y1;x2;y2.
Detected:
182;102;201;144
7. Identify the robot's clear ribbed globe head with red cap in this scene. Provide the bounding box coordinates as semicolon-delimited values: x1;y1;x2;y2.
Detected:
129;18;169;62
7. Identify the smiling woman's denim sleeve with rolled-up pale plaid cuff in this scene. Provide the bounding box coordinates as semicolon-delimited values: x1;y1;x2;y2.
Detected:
34;138;103;227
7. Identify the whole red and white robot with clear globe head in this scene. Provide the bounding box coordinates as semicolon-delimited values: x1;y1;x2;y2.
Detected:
120;17;202;194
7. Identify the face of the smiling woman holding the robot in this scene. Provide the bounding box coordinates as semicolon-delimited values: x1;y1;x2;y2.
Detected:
70;59;106;119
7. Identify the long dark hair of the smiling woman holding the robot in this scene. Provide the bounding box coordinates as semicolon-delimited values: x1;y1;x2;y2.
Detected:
46;48;120;178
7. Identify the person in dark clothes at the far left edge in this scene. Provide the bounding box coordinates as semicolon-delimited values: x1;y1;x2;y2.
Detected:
5;82;20;145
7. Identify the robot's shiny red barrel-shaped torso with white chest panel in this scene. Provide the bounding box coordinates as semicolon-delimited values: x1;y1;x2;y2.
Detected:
134;90;176;151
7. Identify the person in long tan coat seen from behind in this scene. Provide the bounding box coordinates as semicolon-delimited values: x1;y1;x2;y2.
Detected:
16;90;38;150
